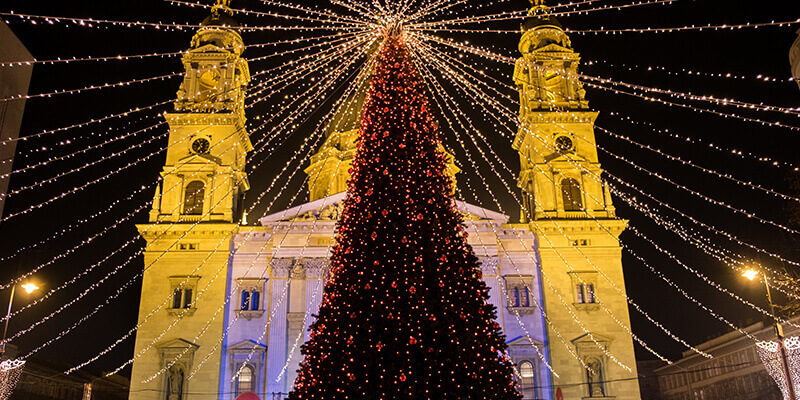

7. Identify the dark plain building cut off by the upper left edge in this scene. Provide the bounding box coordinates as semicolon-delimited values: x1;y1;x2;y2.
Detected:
0;20;33;217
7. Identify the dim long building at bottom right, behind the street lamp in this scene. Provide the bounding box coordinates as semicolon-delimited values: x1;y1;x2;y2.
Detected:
642;320;800;400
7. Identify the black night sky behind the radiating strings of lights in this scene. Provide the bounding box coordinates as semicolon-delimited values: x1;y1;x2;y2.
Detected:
0;0;800;382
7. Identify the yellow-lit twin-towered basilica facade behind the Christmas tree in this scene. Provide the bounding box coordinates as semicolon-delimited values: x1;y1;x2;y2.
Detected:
130;1;639;400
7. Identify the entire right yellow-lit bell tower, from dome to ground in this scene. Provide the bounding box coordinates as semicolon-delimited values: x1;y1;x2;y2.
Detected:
513;0;640;400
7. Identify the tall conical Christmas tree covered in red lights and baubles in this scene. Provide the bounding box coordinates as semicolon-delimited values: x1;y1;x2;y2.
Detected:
289;37;521;400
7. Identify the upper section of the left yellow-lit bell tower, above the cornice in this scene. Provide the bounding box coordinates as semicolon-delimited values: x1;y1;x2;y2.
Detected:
150;2;253;222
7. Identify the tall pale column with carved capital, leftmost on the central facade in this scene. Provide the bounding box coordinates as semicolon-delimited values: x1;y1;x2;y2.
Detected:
264;258;295;398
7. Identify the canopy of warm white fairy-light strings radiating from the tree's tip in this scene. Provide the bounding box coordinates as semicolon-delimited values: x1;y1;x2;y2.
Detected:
0;0;800;390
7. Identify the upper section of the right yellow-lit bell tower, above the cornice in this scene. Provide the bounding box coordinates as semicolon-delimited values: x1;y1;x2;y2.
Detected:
514;0;615;221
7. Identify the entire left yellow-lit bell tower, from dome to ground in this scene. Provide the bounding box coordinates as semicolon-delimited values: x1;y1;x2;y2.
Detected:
130;0;253;400
